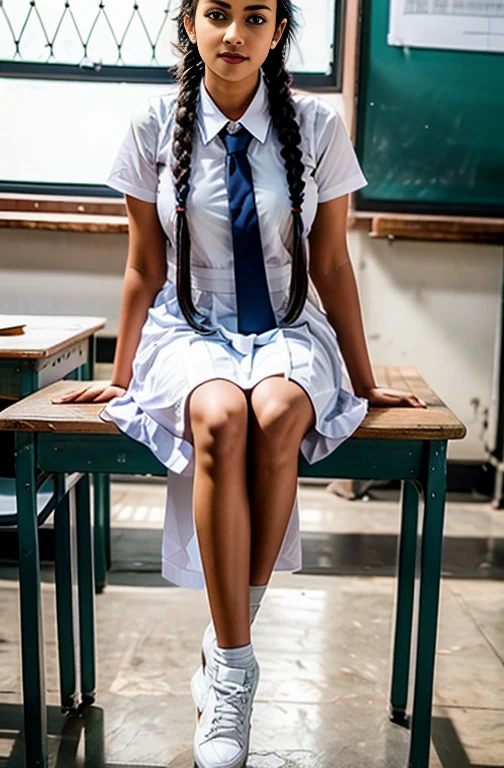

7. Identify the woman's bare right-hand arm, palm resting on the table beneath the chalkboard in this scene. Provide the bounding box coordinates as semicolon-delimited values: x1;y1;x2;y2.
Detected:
309;195;425;407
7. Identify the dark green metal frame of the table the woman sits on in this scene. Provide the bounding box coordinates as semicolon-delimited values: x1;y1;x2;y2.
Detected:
11;431;447;768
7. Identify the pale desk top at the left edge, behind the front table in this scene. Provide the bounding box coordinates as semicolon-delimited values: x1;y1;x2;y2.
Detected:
0;315;107;360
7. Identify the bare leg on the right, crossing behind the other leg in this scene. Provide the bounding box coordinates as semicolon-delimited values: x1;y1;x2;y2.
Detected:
249;376;315;585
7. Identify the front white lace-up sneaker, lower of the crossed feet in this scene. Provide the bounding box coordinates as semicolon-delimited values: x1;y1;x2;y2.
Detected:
194;658;259;768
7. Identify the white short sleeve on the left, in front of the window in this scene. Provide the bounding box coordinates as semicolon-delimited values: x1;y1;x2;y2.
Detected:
107;99;159;203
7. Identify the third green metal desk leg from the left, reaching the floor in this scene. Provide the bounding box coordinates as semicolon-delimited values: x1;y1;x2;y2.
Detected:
75;474;96;705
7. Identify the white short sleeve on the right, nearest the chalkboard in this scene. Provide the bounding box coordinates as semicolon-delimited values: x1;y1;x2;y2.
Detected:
313;101;367;203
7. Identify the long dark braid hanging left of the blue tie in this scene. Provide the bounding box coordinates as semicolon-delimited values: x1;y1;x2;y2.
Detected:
171;46;214;334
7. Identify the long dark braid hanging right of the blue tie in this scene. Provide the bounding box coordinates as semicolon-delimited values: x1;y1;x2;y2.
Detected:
263;50;308;326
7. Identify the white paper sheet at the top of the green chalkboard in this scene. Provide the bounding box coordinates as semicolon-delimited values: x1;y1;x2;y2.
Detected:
388;0;504;53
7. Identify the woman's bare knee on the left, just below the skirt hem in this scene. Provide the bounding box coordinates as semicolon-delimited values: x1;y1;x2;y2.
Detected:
190;388;248;456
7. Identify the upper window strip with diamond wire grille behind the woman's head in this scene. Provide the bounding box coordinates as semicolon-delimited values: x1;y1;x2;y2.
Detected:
0;0;343;88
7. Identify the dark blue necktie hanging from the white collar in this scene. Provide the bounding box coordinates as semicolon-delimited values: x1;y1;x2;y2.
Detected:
219;126;277;333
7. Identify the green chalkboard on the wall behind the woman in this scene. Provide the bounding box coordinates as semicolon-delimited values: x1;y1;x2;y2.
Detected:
356;0;504;216
